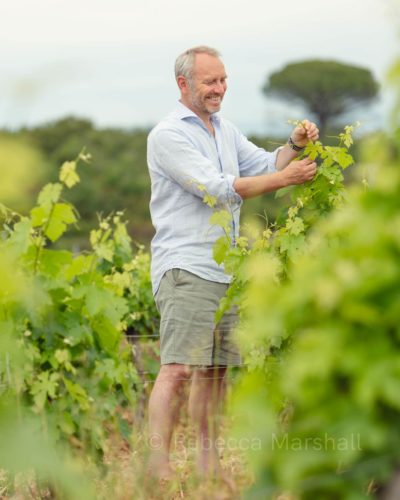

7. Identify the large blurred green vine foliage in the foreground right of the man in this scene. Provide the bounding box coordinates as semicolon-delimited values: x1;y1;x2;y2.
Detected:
223;64;400;500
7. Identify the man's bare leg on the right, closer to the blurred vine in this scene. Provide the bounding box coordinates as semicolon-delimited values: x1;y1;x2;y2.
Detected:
189;366;226;476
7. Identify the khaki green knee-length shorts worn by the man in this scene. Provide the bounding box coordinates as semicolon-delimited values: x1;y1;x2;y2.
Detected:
155;269;241;366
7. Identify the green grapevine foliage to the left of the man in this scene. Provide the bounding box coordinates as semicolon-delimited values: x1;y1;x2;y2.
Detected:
0;150;158;499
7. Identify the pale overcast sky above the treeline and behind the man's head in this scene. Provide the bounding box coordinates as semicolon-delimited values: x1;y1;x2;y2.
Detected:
0;0;400;135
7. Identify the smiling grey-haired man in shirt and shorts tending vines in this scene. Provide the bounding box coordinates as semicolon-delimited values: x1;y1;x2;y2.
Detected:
148;47;318;478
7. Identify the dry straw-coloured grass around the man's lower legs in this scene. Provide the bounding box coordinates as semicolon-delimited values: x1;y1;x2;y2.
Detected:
96;390;252;500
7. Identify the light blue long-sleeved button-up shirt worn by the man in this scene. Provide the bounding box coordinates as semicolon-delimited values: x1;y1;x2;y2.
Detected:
147;102;279;295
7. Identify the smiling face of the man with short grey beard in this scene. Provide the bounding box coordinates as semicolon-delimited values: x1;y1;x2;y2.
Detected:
183;54;227;118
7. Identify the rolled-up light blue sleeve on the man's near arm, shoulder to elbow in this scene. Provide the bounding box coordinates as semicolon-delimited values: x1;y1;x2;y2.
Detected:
148;129;242;209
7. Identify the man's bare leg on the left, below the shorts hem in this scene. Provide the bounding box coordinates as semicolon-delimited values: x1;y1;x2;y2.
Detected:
148;363;191;479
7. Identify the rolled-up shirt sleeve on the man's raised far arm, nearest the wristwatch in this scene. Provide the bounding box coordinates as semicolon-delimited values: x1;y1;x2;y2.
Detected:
236;132;282;177
